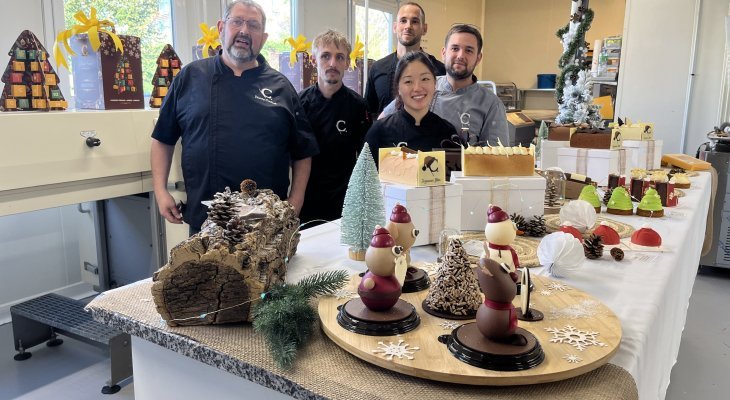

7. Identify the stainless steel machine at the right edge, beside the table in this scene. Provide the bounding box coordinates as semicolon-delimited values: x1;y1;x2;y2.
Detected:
697;132;730;268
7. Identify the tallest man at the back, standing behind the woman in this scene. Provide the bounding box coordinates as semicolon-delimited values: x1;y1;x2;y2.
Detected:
365;2;446;119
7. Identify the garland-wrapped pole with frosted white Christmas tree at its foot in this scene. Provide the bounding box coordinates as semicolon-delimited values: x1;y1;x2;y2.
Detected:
555;0;601;127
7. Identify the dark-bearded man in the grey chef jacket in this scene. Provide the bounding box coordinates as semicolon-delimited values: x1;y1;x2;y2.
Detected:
380;24;509;145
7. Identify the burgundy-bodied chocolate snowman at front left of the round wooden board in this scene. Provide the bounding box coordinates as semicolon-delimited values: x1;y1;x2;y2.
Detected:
357;225;405;311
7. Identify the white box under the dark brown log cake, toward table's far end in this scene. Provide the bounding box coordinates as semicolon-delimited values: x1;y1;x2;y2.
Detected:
558;147;633;186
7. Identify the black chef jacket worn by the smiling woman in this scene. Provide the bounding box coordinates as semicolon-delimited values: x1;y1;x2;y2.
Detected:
365;109;456;164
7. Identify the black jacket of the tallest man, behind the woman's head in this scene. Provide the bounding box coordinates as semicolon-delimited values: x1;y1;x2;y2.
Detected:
365;52;446;119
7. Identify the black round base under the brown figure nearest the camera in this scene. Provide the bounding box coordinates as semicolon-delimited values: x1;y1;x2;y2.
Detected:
446;324;545;371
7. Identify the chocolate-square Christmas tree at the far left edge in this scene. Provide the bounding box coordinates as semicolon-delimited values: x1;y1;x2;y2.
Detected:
0;30;68;111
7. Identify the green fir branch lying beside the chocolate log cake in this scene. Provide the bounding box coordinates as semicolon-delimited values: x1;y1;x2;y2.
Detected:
253;271;350;369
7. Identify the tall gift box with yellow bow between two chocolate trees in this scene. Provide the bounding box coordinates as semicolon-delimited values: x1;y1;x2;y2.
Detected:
53;7;144;110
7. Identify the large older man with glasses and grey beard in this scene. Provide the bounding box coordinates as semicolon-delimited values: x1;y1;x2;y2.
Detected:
150;0;318;234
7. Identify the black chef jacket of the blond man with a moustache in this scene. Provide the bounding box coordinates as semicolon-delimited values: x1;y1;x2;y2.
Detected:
299;84;370;222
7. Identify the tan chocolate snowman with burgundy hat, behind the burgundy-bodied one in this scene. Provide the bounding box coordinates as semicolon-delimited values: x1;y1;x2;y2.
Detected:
385;203;430;293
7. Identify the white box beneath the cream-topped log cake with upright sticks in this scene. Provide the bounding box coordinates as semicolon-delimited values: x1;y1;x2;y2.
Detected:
451;171;545;231
